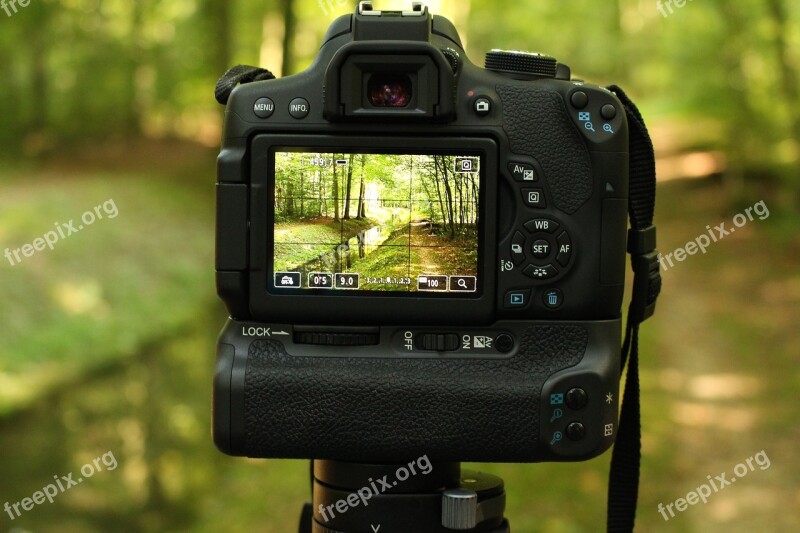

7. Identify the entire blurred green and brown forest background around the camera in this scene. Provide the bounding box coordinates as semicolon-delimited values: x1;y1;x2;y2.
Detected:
0;0;800;533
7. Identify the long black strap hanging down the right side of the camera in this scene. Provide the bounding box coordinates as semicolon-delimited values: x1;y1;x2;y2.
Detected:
606;85;661;533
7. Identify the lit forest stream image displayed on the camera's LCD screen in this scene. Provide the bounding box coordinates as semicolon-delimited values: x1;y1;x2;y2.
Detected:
272;149;481;295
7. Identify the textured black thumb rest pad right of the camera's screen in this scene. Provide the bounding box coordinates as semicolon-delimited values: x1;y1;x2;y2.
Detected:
497;85;592;214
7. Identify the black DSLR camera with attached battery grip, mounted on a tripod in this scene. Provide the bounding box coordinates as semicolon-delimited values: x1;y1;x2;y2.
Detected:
213;3;629;463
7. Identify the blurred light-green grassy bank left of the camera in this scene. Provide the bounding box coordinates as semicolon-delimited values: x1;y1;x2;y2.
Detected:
0;160;213;415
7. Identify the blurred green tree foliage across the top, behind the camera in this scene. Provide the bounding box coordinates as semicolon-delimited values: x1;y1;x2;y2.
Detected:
0;0;800;184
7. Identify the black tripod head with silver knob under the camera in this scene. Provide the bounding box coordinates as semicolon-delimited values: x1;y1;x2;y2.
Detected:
299;456;510;533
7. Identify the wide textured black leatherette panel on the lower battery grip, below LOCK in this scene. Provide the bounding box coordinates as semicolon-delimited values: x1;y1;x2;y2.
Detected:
242;325;588;463
